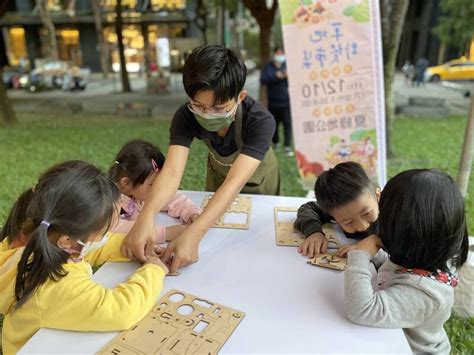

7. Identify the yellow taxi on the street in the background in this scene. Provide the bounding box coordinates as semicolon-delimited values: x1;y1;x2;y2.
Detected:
425;58;474;82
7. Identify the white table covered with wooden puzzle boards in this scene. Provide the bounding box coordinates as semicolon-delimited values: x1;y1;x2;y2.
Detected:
20;192;411;354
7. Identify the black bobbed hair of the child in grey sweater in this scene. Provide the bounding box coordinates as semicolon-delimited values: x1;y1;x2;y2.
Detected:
379;169;469;272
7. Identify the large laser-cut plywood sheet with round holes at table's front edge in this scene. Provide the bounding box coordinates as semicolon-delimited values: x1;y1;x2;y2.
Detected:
98;290;245;355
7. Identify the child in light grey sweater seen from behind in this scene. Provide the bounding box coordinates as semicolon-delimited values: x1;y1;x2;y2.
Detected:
344;169;469;354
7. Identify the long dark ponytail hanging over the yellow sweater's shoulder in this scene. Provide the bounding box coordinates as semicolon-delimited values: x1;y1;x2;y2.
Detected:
15;222;69;308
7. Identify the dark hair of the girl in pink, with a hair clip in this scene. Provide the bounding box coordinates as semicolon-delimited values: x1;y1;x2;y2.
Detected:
109;139;165;186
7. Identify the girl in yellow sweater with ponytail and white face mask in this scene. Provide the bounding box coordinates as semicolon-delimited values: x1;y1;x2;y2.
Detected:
0;161;168;354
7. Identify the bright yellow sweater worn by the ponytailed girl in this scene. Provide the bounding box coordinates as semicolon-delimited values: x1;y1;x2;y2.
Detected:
0;233;165;355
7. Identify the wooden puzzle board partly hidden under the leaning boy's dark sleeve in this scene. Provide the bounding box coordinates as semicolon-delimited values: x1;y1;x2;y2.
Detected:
274;207;341;249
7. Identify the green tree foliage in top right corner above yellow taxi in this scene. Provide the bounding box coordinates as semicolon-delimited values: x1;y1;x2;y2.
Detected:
434;0;474;50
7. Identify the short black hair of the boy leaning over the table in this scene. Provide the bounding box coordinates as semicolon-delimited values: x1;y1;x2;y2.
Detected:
314;161;374;213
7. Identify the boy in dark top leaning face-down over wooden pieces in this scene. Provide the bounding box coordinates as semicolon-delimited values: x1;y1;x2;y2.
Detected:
295;162;380;257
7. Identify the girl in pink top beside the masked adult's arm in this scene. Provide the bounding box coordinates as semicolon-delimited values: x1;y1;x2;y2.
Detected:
109;139;202;243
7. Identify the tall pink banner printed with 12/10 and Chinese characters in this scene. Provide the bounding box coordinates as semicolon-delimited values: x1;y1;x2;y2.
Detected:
279;0;386;190
